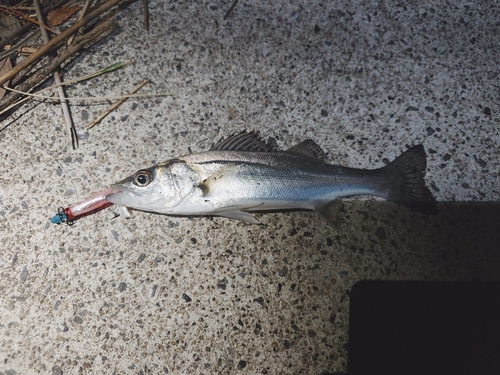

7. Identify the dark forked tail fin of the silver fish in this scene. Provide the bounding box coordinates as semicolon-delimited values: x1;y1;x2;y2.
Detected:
382;145;437;214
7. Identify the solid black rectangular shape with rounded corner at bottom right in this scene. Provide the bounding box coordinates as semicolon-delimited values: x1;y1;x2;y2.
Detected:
347;282;500;375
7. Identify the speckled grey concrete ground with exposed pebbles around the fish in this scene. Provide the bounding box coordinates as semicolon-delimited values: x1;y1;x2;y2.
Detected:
0;0;500;375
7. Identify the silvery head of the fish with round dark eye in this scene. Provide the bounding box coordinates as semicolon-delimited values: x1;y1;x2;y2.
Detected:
106;164;180;213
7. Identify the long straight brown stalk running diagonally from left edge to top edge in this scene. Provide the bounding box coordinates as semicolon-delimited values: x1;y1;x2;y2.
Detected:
0;0;128;86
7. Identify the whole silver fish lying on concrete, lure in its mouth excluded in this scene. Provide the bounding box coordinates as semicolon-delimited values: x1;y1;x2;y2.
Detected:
106;131;437;228
